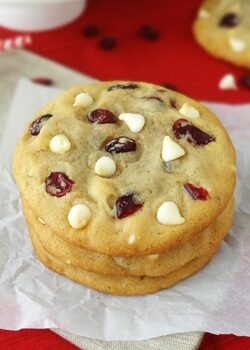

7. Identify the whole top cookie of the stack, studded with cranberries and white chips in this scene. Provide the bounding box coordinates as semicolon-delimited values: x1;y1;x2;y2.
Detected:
13;82;235;256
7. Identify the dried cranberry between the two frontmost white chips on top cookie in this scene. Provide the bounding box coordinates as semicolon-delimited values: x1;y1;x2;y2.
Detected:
115;193;143;219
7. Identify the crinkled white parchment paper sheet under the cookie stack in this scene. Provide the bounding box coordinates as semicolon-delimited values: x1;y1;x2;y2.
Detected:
0;80;250;340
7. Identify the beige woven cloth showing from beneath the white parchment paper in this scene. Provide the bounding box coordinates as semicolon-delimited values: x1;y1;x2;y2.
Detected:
0;50;203;350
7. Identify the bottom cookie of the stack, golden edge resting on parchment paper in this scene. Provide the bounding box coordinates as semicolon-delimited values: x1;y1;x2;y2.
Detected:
30;221;229;296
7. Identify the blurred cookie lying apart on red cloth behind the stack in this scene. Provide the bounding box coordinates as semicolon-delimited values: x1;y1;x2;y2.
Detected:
193;0;250;68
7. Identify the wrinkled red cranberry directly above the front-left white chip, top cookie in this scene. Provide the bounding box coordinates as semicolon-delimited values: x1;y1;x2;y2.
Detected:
45;172;74;197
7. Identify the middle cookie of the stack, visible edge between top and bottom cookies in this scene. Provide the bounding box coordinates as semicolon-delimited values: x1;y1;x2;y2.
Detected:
23;200;233;277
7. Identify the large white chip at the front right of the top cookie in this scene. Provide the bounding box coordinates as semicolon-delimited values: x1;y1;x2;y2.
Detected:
156;201;185;225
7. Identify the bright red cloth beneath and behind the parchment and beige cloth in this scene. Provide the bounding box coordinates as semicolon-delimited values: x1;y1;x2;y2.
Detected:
0;0;250;350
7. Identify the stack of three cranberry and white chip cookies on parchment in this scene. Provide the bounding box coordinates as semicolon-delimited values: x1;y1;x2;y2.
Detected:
13;81;235;295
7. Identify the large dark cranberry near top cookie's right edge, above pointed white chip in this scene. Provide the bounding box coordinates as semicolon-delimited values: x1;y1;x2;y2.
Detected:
172;119;215;146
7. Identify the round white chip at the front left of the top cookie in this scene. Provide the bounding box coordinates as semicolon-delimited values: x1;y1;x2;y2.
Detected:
68;204;91;229
